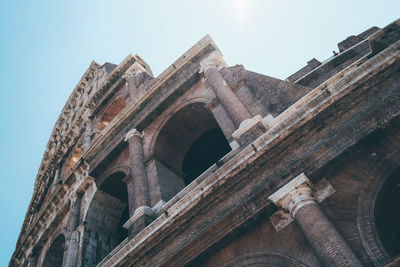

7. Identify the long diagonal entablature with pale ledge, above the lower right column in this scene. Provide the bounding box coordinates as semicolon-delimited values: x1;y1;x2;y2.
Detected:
99;37;400;266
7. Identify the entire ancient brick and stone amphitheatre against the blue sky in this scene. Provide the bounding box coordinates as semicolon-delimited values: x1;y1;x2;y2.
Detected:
10;20;400;267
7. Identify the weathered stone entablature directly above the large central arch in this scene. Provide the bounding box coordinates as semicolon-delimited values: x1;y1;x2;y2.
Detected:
83;35;219;174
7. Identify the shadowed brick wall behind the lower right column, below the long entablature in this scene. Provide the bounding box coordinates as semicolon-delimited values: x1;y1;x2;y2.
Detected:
187;121;400;267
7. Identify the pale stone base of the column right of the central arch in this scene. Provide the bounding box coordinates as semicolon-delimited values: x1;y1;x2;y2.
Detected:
232;115;268;146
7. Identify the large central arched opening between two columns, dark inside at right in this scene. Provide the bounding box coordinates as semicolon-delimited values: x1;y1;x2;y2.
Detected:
154;103;231;200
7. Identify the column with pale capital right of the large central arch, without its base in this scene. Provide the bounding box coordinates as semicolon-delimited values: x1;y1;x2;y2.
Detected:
200;52;252;127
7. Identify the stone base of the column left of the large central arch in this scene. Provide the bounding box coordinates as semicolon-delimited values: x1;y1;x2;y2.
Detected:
123;206;157;237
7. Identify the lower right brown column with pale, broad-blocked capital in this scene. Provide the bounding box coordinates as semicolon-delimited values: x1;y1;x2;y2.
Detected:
269;174;362;266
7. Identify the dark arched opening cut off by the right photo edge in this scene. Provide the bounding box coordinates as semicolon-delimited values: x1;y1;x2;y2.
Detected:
375;168;400;257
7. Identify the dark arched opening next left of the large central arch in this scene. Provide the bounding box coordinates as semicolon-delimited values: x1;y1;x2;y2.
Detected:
83;172;129;266
